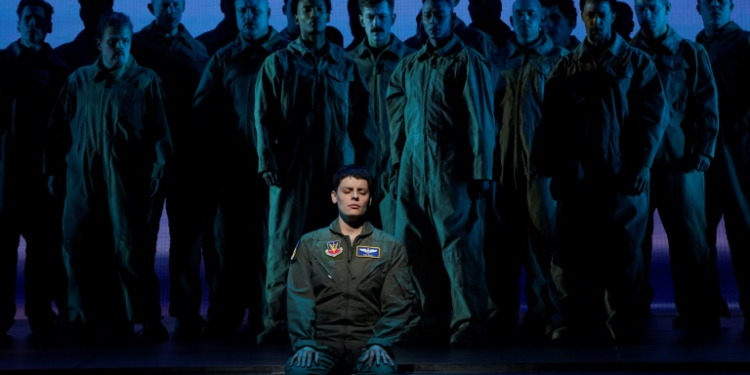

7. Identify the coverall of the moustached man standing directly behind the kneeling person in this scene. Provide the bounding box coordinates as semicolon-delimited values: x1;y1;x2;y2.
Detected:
347;34;415;233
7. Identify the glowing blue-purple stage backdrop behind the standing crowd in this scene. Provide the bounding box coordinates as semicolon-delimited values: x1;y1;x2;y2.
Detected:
0;0;750;318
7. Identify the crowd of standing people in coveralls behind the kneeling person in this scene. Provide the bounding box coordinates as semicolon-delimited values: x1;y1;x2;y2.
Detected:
0;0;750;356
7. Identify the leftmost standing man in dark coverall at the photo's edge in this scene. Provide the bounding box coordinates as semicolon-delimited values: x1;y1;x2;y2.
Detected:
0;0;70;337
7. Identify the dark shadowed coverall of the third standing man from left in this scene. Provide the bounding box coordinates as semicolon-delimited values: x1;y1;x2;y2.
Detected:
131;21;215;328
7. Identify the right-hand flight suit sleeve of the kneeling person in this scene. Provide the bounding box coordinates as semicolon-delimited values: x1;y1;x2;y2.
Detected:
367;243;414;348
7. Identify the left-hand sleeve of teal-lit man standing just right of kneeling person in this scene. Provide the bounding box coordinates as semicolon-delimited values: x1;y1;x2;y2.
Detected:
385;58;410;175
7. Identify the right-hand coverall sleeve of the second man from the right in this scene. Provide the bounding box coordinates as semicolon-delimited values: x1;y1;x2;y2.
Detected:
686;45;719;158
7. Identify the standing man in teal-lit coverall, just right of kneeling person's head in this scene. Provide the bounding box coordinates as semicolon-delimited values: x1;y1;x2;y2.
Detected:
386;0;497;346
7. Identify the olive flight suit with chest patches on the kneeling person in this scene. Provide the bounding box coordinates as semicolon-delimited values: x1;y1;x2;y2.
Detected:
286;219;414;374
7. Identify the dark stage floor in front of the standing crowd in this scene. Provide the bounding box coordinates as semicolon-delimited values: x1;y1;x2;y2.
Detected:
0;315;750;375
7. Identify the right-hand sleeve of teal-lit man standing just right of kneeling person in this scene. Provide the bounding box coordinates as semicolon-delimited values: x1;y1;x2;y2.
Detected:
463;57;497;180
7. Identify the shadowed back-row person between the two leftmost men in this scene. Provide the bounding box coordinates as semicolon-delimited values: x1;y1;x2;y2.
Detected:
55;0;114;70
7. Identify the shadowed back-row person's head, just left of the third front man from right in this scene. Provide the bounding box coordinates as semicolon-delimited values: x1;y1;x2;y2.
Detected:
541;0;581;51
